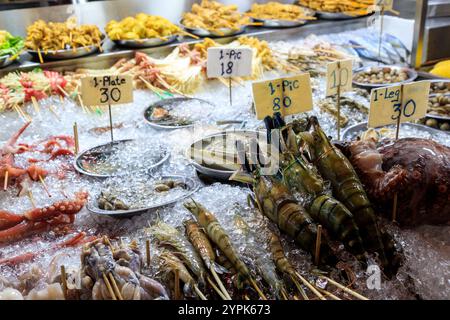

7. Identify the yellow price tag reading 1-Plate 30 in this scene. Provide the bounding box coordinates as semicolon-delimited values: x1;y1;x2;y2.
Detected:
81;75;133;106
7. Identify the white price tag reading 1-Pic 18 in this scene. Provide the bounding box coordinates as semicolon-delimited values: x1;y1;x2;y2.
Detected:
206;47;253;78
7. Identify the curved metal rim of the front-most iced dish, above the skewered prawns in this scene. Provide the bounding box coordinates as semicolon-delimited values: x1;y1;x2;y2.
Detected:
86;175;200;218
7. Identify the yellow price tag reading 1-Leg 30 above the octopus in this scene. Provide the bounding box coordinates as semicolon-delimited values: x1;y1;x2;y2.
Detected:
369;81;430;128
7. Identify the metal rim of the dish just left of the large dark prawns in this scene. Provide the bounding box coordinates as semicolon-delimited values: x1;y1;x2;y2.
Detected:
186;130;263;180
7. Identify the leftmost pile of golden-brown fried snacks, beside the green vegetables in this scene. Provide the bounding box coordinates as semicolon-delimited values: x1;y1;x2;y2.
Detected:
25;18;103;52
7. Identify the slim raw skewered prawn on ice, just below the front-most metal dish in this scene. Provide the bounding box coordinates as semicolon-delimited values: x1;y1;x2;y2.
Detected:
184;200;267;300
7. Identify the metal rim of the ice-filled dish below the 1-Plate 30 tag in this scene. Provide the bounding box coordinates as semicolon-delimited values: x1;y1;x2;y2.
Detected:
74;139;170;178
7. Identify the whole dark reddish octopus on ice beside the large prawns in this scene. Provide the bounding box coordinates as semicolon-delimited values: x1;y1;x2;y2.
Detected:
342;138;450;227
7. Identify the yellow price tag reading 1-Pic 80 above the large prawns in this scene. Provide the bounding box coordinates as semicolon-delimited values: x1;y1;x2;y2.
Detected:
252;73;313;120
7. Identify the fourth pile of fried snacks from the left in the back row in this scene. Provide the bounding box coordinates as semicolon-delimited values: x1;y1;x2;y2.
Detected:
247;2;316;21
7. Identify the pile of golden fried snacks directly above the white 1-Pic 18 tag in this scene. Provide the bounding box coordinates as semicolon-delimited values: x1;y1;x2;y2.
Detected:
182;0;251;31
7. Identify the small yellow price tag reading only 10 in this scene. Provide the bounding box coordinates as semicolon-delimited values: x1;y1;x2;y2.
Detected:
326;59;353;97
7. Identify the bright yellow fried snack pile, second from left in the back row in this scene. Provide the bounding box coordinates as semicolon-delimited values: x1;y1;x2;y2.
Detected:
105;13;183;40
